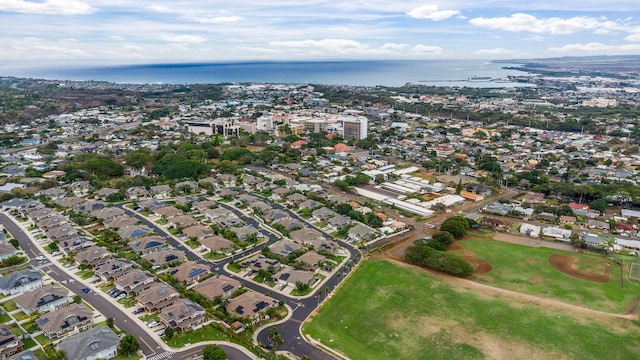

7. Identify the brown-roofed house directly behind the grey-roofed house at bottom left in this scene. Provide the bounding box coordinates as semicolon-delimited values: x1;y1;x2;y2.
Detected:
36;304;93;339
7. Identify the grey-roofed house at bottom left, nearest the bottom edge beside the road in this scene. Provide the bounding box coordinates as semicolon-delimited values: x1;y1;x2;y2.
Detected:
58;326;120;360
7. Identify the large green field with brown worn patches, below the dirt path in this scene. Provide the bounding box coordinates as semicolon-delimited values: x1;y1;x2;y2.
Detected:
303;260;640;360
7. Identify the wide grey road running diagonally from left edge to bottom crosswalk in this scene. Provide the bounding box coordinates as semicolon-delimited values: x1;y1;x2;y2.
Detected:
0;213;251;360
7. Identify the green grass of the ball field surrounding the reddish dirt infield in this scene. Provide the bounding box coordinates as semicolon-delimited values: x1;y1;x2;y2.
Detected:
459;240;640;313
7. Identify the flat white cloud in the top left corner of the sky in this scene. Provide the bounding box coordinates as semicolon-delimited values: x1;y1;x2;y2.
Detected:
0;0;96;15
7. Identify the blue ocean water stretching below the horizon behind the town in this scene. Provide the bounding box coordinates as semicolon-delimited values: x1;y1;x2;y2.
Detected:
20;60;526;87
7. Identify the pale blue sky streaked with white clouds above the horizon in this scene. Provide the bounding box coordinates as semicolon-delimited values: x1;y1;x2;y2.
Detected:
0;0;640;68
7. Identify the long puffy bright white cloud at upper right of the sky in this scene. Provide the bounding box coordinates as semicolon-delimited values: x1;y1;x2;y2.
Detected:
469;13;625;35
